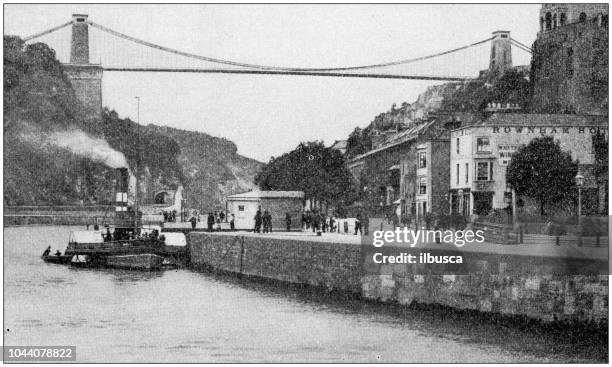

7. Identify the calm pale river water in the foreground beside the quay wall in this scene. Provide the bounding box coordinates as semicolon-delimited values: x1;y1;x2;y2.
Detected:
4;226;604;363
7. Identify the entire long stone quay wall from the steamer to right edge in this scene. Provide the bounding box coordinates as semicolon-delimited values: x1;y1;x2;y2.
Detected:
188;232;608;322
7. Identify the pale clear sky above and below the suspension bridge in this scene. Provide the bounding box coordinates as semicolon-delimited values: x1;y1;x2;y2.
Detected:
4;4;540;162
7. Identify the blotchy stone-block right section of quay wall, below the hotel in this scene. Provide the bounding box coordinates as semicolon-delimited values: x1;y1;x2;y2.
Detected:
362;250;608;321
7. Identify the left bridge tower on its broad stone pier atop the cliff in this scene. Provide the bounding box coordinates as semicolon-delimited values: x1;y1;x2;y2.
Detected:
64;14;102;121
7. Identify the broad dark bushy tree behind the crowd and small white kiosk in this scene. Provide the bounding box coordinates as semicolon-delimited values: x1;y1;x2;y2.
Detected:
255;141;354;210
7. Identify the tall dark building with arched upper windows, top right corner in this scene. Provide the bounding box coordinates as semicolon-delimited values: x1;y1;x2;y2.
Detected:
531;4;609;115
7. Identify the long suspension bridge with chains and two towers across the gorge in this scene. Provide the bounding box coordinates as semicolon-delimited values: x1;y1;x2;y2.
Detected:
24;14;531;81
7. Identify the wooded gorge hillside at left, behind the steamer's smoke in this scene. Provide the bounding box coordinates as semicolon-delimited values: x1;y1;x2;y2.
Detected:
3;36;260;210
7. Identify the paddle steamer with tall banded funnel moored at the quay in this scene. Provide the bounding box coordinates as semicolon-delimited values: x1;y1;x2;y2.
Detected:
42;168;187;270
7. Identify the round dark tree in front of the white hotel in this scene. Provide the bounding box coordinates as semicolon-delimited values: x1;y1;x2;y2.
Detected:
506;136;578;215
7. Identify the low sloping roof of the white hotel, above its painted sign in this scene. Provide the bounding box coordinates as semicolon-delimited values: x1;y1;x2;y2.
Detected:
460;113;608;128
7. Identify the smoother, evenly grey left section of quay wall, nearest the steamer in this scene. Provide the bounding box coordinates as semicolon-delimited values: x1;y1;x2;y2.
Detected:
187;232;361;293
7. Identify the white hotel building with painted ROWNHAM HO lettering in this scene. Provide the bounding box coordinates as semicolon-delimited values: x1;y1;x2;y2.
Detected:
450;113;608;216
